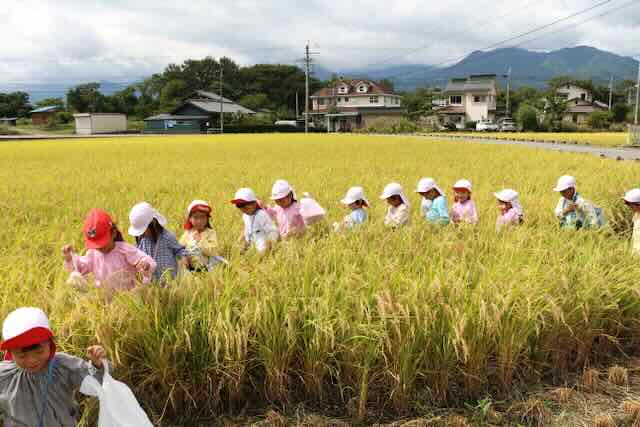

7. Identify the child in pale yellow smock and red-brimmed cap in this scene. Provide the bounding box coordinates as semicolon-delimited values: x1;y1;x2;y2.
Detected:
180;200;227;272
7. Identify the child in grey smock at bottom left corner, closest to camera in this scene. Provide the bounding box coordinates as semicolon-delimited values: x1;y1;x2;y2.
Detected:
0;307;106;427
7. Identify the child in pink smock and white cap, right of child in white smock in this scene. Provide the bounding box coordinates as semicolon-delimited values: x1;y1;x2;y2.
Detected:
266;179;306;239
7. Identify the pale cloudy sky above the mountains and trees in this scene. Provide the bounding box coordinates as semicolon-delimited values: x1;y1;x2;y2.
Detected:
0;0;640;86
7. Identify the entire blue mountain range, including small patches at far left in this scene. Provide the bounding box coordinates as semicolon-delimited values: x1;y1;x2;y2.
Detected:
0;46;638;102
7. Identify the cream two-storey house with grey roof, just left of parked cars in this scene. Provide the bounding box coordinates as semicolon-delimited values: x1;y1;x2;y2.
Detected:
434;74;500;129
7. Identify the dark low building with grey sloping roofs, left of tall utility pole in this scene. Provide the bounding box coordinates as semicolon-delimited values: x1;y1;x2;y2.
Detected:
144;90;256;133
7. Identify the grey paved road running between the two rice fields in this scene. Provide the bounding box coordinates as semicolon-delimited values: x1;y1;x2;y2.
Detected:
422;135;640;161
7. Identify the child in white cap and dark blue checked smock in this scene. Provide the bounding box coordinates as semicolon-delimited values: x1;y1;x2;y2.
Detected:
129;202;189;283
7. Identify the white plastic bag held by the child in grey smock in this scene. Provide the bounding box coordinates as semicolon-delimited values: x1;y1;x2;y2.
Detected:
80;360;153;427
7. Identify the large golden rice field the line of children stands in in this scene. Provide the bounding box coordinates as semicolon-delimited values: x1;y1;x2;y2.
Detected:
0;135;640;425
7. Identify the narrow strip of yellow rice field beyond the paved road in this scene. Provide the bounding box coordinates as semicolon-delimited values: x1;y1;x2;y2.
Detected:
434;132;629;147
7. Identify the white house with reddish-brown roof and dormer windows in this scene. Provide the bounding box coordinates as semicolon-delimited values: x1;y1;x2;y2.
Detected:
310;79;406;132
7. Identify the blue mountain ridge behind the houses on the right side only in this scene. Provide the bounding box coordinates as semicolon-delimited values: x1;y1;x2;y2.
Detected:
328;46;638;90
